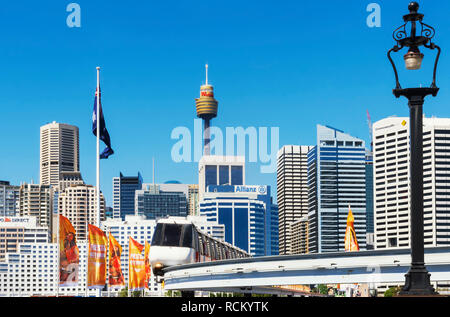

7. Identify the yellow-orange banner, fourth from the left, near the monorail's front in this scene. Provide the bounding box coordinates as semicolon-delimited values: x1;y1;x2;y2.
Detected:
128;237;145;291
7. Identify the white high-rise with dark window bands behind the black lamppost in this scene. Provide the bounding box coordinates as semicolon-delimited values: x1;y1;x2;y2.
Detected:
373;117;450;249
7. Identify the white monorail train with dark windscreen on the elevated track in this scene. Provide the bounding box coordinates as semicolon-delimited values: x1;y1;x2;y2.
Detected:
149;217;250;276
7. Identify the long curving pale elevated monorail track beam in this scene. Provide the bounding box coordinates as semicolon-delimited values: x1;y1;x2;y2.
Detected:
164;247;450;292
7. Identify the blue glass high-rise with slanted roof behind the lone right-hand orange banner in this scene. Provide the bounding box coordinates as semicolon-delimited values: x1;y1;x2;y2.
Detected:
308;125;366;253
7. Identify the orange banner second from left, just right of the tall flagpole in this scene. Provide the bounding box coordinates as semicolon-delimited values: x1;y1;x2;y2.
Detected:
88;224;108;288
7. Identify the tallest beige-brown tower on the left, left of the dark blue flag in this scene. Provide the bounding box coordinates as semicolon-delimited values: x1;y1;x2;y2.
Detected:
39;122;80;186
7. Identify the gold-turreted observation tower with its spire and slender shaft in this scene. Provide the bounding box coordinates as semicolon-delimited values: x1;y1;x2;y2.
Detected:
195;64;218;155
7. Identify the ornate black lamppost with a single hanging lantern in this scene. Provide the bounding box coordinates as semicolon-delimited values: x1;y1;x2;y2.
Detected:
388;2;441;295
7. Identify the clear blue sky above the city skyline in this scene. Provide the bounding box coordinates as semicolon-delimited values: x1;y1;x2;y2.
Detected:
0;0;450;205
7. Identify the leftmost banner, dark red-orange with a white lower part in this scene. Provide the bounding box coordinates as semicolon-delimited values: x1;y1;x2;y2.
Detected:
58;215;80;286
